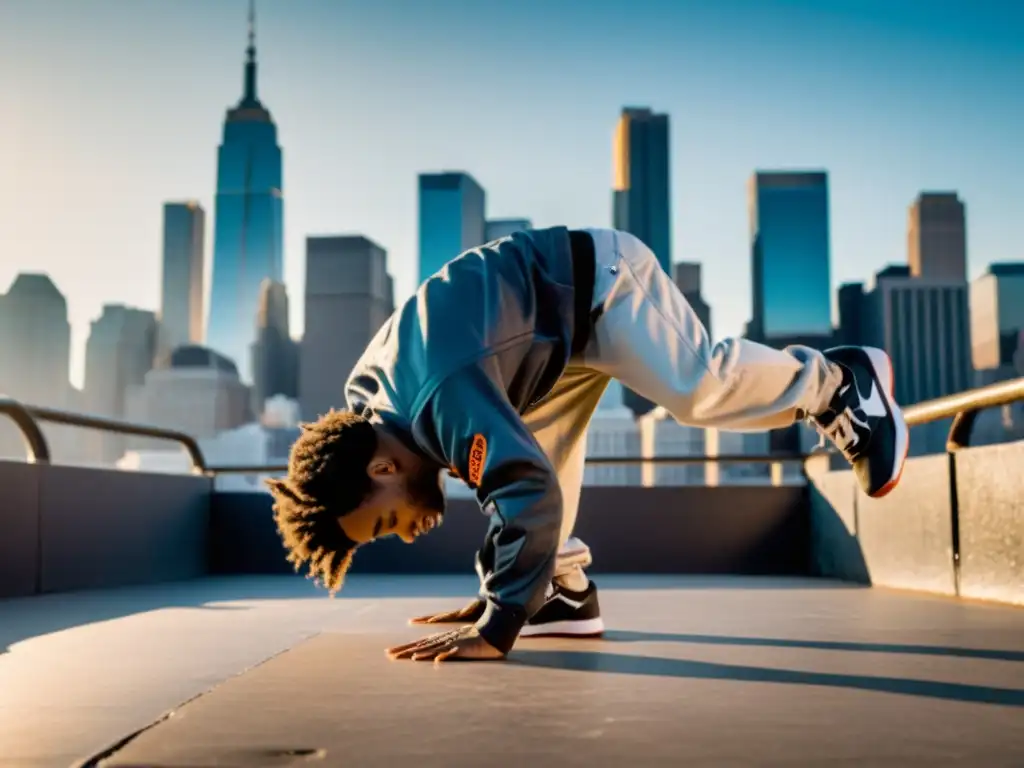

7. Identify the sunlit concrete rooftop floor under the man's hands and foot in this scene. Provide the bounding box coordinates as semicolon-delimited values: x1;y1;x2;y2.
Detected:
0;575;1024;768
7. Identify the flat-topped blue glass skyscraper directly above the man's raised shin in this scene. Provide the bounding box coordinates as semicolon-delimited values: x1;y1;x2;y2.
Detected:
748;171;833;345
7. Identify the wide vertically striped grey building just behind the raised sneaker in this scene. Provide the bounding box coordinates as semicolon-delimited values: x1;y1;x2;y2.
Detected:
861;267;972;406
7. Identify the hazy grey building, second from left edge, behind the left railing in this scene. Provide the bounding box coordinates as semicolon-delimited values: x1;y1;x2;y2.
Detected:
85;304;158;463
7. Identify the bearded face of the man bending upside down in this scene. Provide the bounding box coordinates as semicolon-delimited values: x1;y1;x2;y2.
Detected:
339;460;444;544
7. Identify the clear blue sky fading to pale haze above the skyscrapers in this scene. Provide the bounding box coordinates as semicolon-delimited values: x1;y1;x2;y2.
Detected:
0;0;1024;384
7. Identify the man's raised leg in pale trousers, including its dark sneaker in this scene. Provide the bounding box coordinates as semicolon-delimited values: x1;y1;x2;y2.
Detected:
584;229;908;497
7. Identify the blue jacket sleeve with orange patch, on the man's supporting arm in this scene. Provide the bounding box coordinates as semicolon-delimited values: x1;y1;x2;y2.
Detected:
420;359;562;653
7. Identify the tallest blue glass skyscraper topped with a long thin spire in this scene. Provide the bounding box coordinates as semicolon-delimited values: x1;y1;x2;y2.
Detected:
206;0;284;382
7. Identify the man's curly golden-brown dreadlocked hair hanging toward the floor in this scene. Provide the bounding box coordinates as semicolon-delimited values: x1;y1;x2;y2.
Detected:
267;411;377;596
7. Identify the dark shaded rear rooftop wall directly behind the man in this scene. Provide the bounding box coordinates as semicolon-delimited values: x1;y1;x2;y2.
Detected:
211;486;809;574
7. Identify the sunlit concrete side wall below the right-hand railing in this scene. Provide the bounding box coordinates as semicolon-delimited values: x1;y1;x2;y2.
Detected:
809;441;1024;605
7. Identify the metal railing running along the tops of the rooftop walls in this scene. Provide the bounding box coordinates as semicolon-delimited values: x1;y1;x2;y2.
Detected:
0;378;1024;475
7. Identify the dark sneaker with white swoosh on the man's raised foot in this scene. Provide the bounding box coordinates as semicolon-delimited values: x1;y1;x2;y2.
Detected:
810;347;910;499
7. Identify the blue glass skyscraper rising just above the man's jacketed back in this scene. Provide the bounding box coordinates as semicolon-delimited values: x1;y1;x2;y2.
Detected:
420;171;486;283
